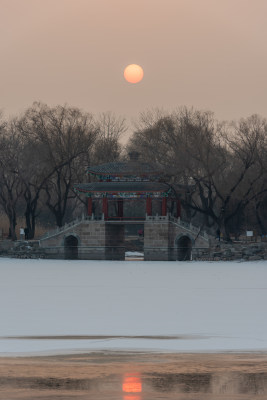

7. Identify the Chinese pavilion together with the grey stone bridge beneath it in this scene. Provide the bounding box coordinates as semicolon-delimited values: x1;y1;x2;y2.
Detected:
40;153;209;261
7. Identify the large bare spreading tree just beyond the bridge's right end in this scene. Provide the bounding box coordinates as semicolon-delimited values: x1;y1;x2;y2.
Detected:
170;111;267;240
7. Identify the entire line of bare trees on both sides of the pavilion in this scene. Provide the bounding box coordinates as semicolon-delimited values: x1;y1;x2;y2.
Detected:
0;103;267;240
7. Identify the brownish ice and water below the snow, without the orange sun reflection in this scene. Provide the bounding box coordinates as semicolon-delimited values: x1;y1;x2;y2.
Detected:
0;351;267;400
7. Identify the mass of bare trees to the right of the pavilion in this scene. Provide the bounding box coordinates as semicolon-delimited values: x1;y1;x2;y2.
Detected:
128;107;267;240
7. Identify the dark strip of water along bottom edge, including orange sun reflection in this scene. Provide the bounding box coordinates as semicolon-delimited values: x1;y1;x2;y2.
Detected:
0;368;267;400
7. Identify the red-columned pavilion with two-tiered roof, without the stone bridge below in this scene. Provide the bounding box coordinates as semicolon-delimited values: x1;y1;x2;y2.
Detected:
74;153;181;221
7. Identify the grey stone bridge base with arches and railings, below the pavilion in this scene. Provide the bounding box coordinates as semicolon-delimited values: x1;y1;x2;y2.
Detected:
40;215;210;261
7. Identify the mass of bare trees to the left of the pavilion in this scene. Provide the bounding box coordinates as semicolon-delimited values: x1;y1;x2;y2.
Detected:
0;103;126;240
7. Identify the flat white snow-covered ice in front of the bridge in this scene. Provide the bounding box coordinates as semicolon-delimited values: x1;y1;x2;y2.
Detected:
0;258;267;355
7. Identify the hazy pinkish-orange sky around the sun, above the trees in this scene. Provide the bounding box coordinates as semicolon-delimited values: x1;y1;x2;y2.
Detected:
0;0;267;136
